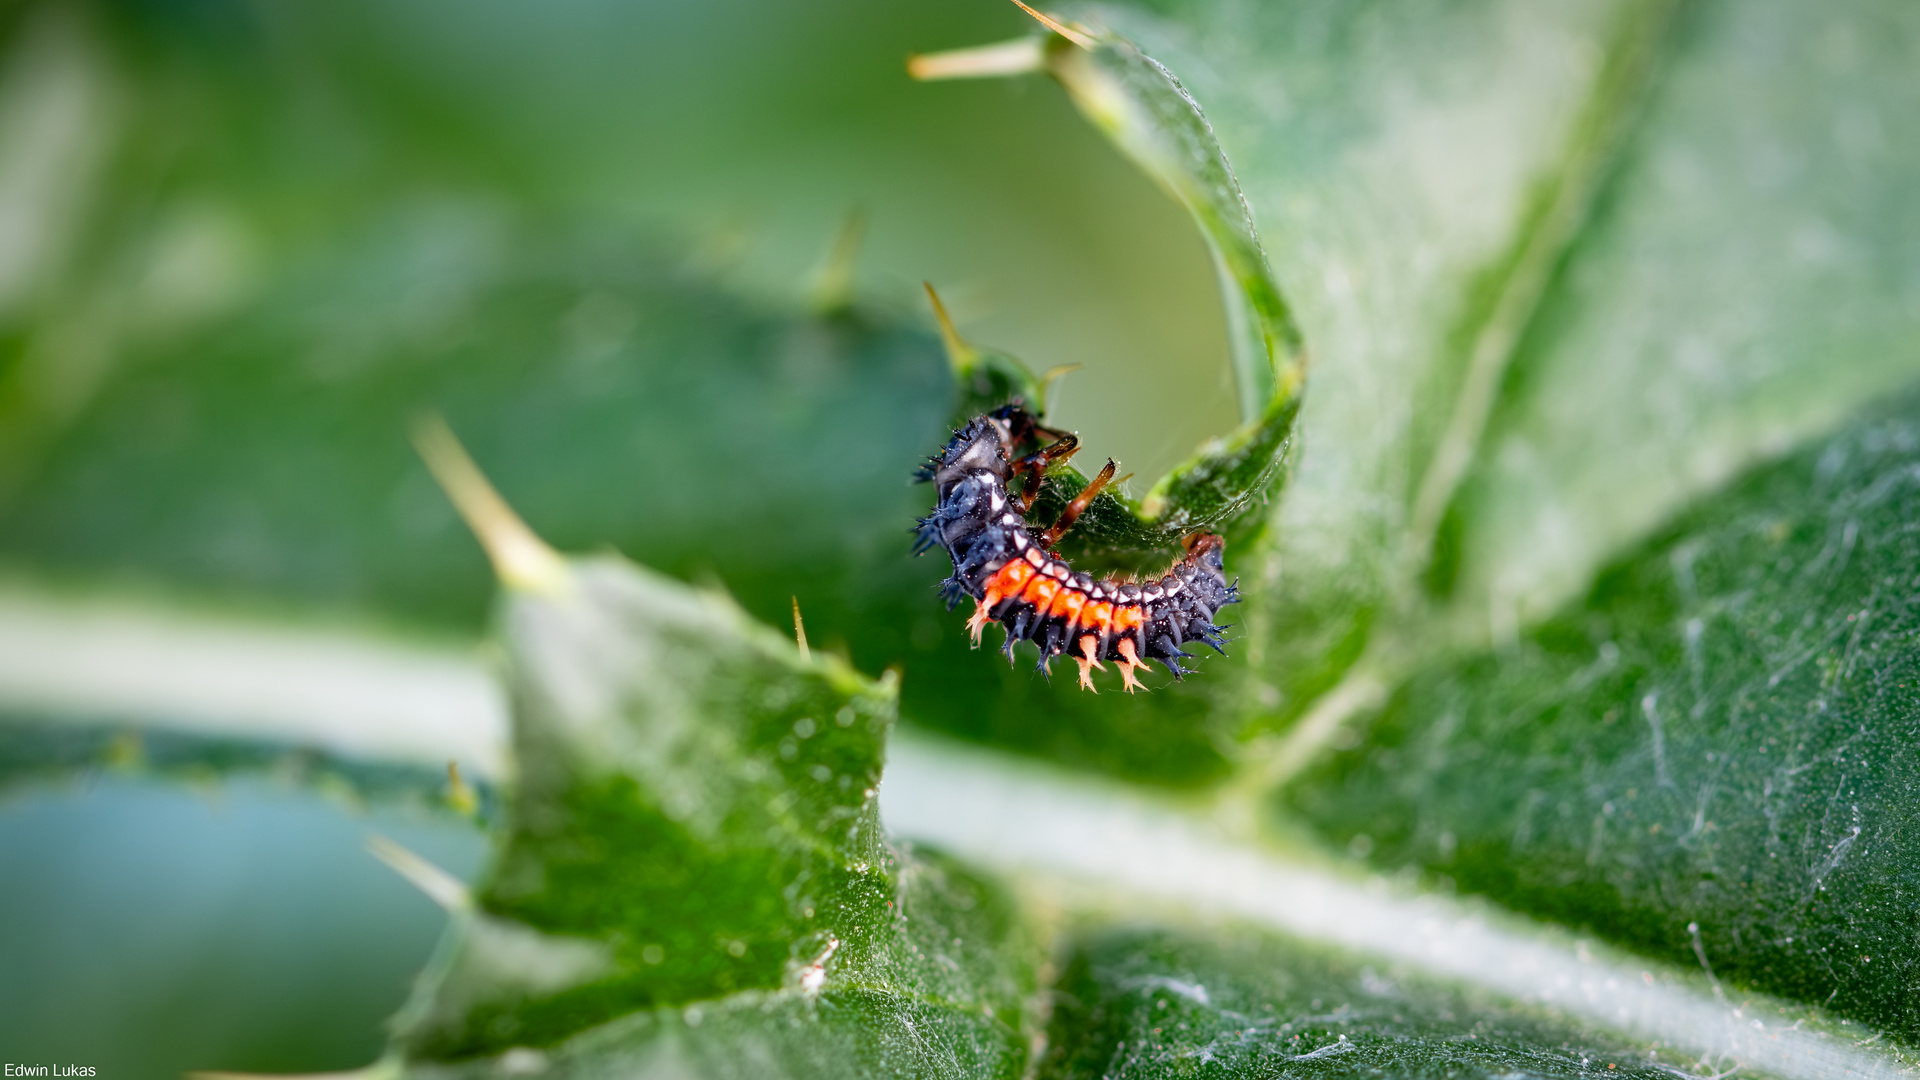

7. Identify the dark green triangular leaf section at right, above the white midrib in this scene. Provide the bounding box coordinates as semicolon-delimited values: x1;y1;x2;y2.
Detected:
1286;390;1920;1040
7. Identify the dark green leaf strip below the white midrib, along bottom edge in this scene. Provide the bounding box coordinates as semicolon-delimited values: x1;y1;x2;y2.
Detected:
1039;914;1678;1080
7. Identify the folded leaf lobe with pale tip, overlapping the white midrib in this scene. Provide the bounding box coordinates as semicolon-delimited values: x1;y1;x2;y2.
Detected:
385;545;1035;1076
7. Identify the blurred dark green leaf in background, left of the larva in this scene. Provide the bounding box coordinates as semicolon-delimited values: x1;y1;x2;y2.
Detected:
0;222;947;634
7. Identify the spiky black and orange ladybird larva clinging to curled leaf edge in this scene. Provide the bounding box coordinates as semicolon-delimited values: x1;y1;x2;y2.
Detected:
914;404;1238;692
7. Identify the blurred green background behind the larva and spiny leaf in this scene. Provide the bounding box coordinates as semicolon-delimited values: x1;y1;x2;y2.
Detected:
0;0;1235;1078
